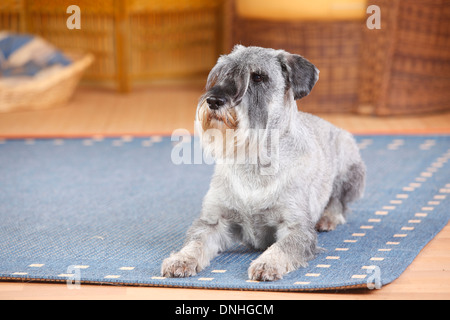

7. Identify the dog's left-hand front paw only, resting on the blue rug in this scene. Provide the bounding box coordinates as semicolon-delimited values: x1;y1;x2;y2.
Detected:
161;252;200;278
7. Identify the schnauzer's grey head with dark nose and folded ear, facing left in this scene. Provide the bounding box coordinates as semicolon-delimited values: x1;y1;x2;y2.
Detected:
197;45;319;130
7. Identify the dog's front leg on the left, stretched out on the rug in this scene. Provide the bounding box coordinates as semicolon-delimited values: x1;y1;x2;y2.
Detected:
161;214;231;277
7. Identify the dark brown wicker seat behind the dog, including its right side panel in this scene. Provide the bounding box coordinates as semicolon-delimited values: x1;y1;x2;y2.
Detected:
227;0;450;115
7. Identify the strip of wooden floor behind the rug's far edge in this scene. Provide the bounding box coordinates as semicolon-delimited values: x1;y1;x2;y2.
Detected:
0;85;450;137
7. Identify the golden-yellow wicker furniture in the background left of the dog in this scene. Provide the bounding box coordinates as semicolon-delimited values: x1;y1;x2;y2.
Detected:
0;0;223;92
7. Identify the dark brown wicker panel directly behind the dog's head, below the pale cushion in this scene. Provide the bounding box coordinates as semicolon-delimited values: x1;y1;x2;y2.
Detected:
229;0;365;113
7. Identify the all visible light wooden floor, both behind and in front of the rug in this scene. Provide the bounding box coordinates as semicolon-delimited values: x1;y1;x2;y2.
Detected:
0;84;450;300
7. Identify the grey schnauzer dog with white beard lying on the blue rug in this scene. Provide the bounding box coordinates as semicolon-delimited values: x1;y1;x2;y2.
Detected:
161;45;366;281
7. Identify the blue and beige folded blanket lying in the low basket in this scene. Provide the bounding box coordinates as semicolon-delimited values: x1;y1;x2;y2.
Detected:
0;32;72;77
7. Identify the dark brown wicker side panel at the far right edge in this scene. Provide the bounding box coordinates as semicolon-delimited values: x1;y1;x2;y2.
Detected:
358;0;450;115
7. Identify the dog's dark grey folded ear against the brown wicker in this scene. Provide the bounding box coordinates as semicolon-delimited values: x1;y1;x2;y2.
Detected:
279;53;319;100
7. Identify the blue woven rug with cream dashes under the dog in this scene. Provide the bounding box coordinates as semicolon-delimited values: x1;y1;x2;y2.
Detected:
0;136;450;291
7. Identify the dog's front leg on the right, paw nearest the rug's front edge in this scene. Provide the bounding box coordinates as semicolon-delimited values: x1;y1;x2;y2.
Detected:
248;221;317;281
